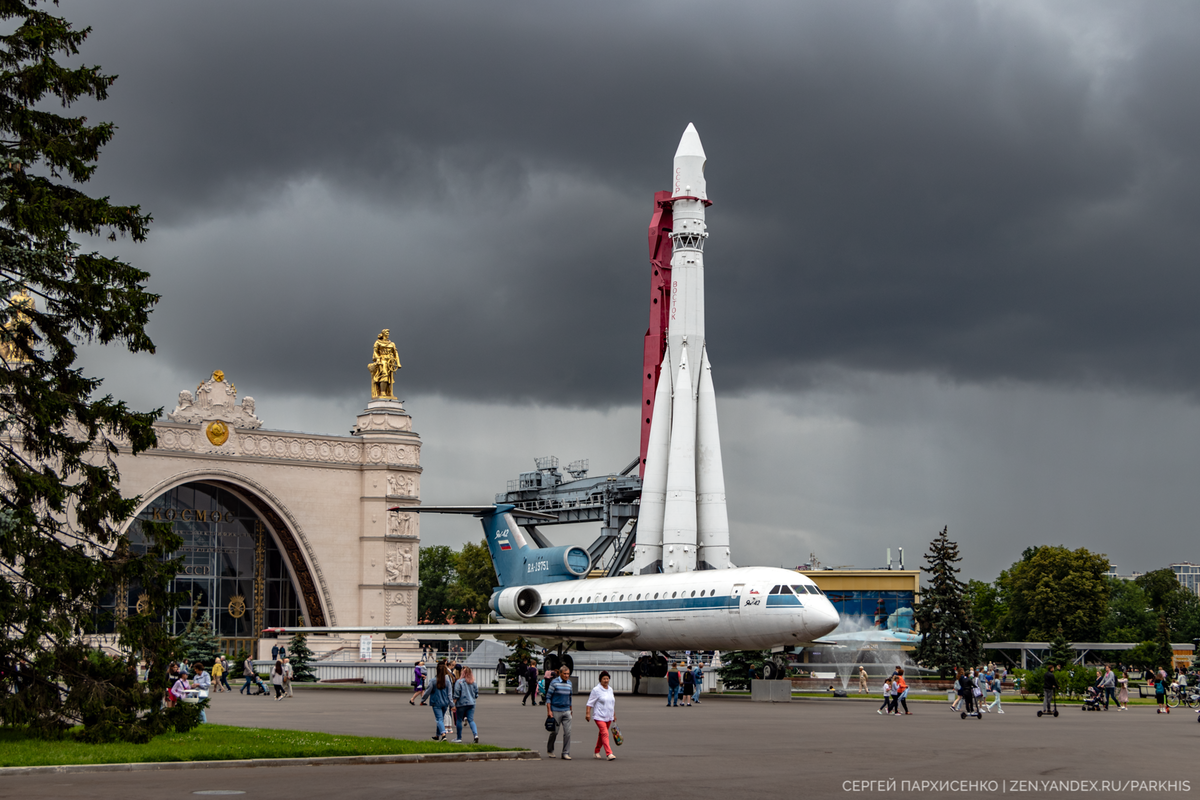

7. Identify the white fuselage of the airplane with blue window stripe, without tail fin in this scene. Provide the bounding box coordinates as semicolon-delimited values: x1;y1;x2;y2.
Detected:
497;567;839;650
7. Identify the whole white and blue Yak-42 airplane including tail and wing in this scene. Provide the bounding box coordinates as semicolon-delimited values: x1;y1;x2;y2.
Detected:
268;504;839;678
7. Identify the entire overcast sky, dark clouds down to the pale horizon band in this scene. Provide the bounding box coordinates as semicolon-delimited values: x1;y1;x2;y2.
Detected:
61;0;1200;579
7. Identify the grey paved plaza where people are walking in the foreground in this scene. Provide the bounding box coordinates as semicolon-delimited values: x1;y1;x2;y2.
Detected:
0;688;1200;800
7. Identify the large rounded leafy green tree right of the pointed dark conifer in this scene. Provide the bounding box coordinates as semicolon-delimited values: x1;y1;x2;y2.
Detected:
996;545;1109;642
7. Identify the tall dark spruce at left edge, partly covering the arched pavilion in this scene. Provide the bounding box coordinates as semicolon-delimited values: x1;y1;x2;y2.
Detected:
0;0;180;741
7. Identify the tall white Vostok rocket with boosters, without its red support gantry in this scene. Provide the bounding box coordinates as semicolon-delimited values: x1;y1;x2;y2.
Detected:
632;124;733;575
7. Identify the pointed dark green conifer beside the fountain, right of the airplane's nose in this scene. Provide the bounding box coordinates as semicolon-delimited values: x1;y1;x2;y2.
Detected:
913;528;983;678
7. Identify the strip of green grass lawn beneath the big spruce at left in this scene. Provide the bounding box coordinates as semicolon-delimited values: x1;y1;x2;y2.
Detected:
0;724;523;766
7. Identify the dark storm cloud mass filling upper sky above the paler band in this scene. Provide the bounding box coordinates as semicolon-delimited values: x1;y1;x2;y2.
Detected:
64;0;1200;405
